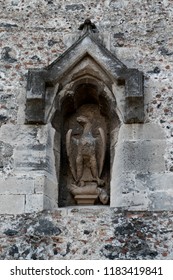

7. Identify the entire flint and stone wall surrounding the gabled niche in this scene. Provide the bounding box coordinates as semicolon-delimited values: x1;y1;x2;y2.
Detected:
0;0;173;259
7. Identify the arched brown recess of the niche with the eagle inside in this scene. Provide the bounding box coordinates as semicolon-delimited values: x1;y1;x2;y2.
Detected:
52;80;120;206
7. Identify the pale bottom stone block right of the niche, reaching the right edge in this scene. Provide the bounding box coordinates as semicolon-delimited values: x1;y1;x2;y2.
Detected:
111;173;173;211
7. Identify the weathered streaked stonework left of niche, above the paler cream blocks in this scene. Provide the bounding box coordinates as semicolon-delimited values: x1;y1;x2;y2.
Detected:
13;125;54;174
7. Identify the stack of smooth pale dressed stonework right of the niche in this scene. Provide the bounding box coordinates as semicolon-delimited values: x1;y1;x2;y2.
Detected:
110;124;169;210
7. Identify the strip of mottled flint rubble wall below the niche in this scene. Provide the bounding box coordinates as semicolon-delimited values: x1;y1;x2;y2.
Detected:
0;210;173;260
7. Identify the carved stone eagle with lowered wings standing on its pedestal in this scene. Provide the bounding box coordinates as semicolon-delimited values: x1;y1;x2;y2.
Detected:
66;115;108;204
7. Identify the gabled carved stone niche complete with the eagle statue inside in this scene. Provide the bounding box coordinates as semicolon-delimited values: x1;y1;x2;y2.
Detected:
26;23;144;207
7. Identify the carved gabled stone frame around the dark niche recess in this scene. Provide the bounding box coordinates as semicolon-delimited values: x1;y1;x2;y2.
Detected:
25;31;144;208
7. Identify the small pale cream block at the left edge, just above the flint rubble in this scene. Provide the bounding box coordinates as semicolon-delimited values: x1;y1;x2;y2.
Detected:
0;194;25;215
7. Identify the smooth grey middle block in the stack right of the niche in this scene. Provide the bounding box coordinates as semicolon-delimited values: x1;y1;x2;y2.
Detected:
113;140;165;174
